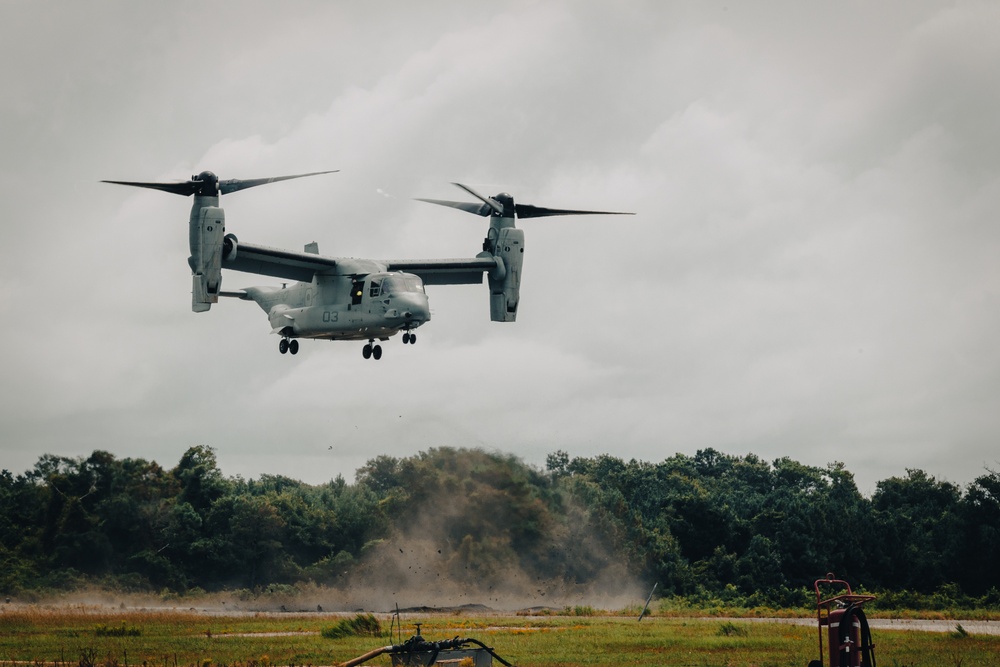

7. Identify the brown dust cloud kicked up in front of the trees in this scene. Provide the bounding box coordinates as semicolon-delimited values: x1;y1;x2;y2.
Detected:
342;494;648;611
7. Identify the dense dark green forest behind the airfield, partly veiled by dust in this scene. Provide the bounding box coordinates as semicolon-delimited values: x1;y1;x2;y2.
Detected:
0;446;1000;608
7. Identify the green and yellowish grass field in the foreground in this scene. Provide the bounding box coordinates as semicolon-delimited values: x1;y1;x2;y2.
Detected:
0;607;1000;667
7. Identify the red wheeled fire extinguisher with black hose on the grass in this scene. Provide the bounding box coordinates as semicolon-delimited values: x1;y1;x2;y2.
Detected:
809;572;875;667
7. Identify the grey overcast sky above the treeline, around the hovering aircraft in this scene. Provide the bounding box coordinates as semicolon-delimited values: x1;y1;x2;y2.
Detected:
0;0;1000;493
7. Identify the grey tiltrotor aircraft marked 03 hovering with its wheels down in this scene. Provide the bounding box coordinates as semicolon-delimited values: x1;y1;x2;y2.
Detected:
102;171;632;359
